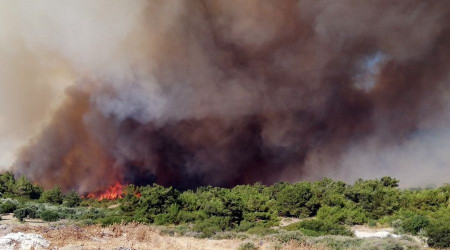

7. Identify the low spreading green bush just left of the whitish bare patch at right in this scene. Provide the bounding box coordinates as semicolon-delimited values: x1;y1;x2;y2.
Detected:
285;219;353;236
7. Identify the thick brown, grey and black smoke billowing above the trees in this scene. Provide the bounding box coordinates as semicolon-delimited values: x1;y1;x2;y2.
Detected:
2;0;450;192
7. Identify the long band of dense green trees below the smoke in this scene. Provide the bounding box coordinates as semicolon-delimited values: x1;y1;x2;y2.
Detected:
0;173;450;247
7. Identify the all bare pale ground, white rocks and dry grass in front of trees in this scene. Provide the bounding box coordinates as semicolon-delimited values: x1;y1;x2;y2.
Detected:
0;214;426;250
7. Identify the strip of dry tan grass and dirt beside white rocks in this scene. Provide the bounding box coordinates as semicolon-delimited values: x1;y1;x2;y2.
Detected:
0;215;317;250
